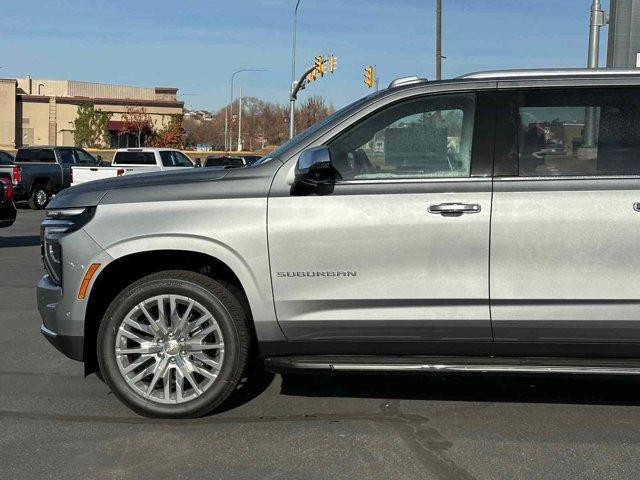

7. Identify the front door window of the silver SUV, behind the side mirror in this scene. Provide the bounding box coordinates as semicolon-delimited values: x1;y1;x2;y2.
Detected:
328;94;475;180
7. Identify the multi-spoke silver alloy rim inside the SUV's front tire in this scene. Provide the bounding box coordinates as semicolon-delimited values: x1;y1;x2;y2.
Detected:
114;294;224;404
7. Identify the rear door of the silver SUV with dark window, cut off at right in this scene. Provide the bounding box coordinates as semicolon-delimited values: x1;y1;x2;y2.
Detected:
490;87;640;343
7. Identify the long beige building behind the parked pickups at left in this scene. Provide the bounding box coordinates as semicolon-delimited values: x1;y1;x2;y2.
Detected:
0;76;184;149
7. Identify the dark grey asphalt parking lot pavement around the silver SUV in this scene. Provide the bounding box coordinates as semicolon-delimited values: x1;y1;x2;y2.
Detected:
0;208;640;480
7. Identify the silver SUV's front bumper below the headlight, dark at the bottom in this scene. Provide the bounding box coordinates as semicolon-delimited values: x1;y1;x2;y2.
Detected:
37;275;84;362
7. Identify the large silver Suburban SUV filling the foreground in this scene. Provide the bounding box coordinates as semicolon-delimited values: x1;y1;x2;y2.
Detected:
38;70;640;417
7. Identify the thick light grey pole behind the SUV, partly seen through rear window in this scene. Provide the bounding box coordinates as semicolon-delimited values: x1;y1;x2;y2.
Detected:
577;0;608;154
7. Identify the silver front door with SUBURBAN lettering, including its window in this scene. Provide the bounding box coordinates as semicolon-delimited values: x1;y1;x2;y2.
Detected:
268;94;491;342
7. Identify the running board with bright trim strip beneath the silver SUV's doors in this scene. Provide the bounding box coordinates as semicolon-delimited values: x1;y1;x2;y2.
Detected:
265;355;640;375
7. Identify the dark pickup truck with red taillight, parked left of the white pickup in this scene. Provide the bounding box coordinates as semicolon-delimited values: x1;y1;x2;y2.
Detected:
5;146;100;210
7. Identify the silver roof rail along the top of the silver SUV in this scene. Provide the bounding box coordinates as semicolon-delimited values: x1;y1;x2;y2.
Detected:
456;68;640;80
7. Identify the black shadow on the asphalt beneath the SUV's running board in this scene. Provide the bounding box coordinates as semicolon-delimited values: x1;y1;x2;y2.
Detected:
281;374;640;405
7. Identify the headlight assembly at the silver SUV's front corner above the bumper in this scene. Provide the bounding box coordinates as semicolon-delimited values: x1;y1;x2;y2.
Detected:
40;207;95;285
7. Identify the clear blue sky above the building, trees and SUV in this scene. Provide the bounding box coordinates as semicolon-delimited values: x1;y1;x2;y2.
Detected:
0;0;609;110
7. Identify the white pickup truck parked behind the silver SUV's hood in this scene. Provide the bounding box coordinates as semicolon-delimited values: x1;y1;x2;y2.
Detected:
71;148;196;185
